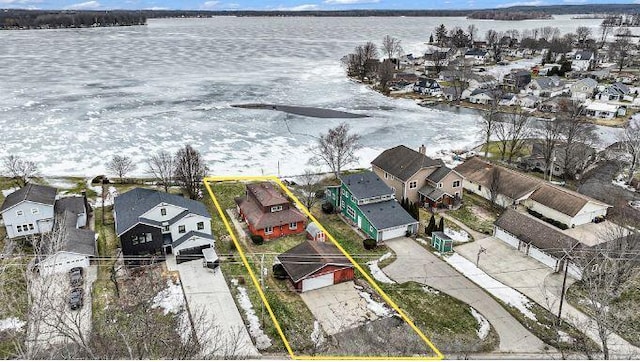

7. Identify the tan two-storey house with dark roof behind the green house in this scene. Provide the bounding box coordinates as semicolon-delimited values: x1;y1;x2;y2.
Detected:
371;145;462;207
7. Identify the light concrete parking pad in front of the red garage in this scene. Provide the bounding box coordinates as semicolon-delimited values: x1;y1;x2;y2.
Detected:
300;281;378;335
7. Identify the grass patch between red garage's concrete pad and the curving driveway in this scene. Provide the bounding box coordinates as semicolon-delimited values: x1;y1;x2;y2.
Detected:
381;282;498;352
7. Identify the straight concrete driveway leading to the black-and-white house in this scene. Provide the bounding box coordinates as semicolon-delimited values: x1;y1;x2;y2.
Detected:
167;255;260;359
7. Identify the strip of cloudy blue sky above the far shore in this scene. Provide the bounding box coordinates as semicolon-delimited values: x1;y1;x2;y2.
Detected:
0;0;640;10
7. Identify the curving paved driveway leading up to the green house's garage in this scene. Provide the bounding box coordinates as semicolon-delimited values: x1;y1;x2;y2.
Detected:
383;238;544;352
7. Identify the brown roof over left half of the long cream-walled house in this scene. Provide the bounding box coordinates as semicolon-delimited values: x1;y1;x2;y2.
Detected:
454;156;544;200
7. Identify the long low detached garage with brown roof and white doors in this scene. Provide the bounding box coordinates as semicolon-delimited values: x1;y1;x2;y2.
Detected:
493;209;582;272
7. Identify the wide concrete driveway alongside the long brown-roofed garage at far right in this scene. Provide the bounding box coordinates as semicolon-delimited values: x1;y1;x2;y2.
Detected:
455;237;640;359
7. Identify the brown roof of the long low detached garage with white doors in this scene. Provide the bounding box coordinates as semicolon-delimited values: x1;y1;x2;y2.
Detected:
494;208;582;258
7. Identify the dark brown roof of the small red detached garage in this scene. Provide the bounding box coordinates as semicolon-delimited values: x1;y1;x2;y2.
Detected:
278;240;353;283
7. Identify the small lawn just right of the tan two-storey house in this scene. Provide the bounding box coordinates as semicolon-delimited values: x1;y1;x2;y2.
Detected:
447;192;500;234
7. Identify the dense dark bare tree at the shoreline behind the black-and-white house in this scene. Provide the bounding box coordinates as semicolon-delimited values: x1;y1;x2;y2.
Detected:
175;145;209;200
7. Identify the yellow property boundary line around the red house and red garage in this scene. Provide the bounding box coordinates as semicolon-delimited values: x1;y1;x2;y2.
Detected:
203;176;444;360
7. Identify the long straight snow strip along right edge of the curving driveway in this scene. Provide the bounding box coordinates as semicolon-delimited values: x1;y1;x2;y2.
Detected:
444;253;537;320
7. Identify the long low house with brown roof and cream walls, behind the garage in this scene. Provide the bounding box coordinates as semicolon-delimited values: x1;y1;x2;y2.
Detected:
455;157;611;227
